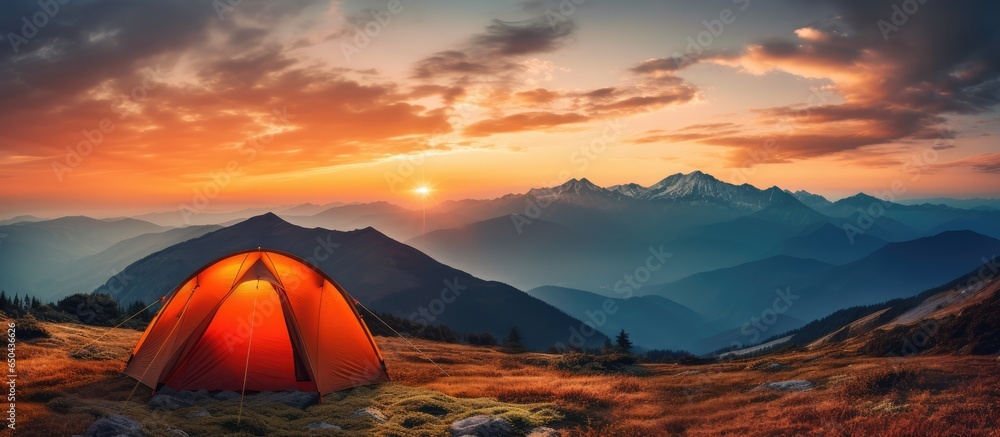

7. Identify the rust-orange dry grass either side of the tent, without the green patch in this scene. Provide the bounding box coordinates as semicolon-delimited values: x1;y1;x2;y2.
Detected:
18;318;1000;437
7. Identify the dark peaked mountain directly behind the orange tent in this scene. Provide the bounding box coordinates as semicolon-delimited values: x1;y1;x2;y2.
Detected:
97;213;604;349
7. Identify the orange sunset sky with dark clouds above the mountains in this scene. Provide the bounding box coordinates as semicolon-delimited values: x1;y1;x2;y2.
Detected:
0;0;1000;217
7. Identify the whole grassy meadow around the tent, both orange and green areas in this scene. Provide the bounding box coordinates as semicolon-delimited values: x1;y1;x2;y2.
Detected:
11;318;1000;437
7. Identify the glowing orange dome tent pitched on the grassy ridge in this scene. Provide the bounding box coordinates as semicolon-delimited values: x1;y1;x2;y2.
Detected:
125;249;389;394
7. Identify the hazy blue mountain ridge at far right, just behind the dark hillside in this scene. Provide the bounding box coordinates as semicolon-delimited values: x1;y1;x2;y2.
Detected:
640;231;1000;328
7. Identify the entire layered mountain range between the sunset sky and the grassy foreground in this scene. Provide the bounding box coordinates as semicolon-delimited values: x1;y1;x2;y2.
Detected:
0;172;1000;353
